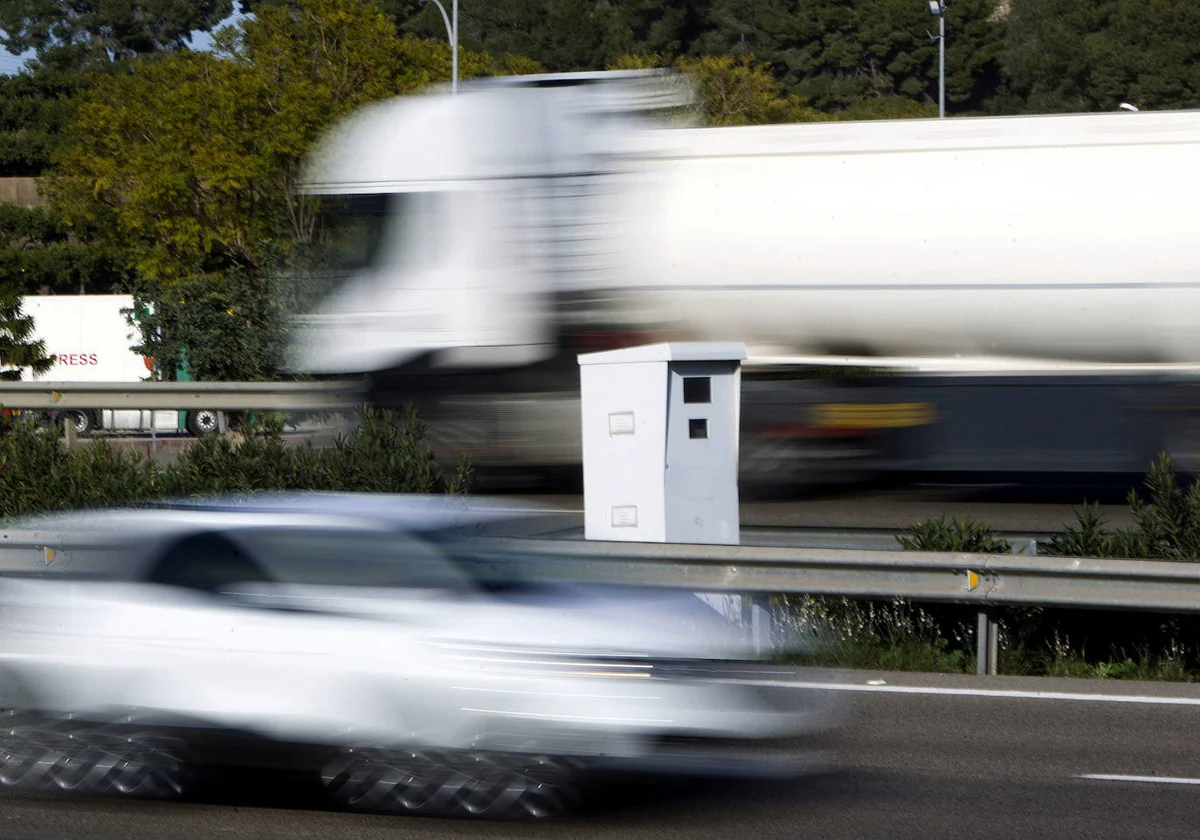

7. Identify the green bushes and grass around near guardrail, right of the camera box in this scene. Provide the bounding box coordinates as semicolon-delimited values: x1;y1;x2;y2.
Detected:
776;454;1200;682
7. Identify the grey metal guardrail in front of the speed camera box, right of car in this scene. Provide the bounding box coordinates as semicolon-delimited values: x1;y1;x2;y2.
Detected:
492;539;1200;673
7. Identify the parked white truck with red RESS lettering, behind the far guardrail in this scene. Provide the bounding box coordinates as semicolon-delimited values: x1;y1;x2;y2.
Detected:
22;295;222;437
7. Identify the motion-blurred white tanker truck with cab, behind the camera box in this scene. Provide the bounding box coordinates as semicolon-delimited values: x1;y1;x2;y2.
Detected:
294;73;1200;492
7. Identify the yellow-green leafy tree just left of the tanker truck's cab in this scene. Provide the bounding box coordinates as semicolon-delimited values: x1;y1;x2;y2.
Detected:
46;0;523;378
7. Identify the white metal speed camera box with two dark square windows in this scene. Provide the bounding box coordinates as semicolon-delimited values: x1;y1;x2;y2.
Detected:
578;342;745;545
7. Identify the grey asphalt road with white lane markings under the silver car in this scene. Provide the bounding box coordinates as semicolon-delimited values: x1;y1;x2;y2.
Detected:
0;674;1200;840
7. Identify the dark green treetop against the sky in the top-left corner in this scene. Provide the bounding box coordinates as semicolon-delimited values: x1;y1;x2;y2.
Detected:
0;0;233;70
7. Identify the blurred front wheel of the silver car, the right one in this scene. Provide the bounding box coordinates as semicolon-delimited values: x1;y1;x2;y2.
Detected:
322;750;580;820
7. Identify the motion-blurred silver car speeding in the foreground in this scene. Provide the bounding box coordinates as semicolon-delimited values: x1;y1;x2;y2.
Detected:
0;494;836;817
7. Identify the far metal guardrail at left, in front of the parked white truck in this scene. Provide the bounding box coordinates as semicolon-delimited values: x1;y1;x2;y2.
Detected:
0;382;362;412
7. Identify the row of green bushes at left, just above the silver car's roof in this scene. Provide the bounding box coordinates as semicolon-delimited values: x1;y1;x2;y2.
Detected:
0;409;472;517
